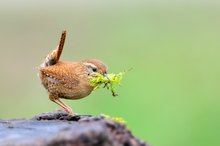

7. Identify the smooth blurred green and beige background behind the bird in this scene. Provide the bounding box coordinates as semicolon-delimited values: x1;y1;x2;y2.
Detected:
0;0;220;146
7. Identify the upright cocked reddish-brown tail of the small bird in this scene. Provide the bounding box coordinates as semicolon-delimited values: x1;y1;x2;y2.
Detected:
40;31;66;67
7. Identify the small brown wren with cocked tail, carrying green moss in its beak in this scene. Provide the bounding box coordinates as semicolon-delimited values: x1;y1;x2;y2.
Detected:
39;31;108;114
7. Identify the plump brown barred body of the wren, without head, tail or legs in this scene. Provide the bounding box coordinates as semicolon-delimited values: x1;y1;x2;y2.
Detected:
40;62;93;99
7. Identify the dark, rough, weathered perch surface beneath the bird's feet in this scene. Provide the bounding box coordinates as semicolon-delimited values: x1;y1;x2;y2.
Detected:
0;112;147;146
